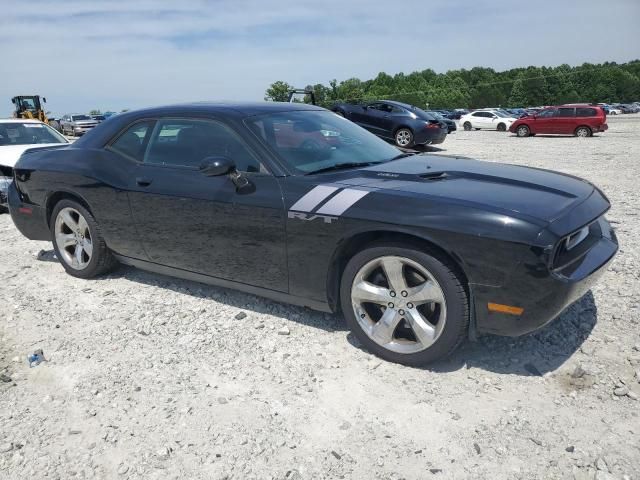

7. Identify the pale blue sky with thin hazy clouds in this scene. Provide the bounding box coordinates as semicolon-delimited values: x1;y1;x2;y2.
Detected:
0;0;640;116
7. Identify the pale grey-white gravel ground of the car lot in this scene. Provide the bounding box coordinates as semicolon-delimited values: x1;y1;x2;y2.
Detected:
0;115;640;480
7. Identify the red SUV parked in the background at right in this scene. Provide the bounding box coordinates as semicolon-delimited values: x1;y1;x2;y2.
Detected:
509;105;609;137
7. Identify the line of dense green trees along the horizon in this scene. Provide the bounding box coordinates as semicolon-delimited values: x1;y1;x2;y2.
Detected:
265;60;640;108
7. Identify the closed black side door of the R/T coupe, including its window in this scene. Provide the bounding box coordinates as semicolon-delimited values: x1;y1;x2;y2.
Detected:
111;118;288;292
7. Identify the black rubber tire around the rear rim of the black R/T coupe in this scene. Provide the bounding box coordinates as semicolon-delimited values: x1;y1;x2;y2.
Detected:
49;199;117;278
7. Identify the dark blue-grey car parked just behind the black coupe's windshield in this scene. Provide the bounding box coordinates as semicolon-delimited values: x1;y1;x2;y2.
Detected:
331;100;448;148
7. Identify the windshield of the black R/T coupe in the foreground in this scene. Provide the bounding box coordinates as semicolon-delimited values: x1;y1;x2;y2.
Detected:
245;111;399;174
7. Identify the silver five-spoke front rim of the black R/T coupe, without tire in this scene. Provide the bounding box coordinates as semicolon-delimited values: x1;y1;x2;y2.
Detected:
351;256;447;354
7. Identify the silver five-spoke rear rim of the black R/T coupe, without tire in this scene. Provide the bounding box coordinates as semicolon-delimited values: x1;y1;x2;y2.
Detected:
55;207;93;270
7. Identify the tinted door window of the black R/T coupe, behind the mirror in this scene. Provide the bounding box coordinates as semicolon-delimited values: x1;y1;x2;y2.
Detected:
144;119;265;172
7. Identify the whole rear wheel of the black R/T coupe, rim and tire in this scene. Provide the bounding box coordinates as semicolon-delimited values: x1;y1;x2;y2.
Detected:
49;199;116;278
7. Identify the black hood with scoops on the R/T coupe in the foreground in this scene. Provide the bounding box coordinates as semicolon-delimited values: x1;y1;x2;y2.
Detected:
336;155;595;222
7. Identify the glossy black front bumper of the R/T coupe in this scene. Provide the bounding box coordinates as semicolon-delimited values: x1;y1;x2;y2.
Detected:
472;217;618;336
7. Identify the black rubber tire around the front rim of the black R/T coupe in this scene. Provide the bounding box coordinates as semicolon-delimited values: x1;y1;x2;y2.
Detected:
340;242;469;367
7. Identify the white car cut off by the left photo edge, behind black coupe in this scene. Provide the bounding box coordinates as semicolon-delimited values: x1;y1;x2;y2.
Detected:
0;118;69;210
